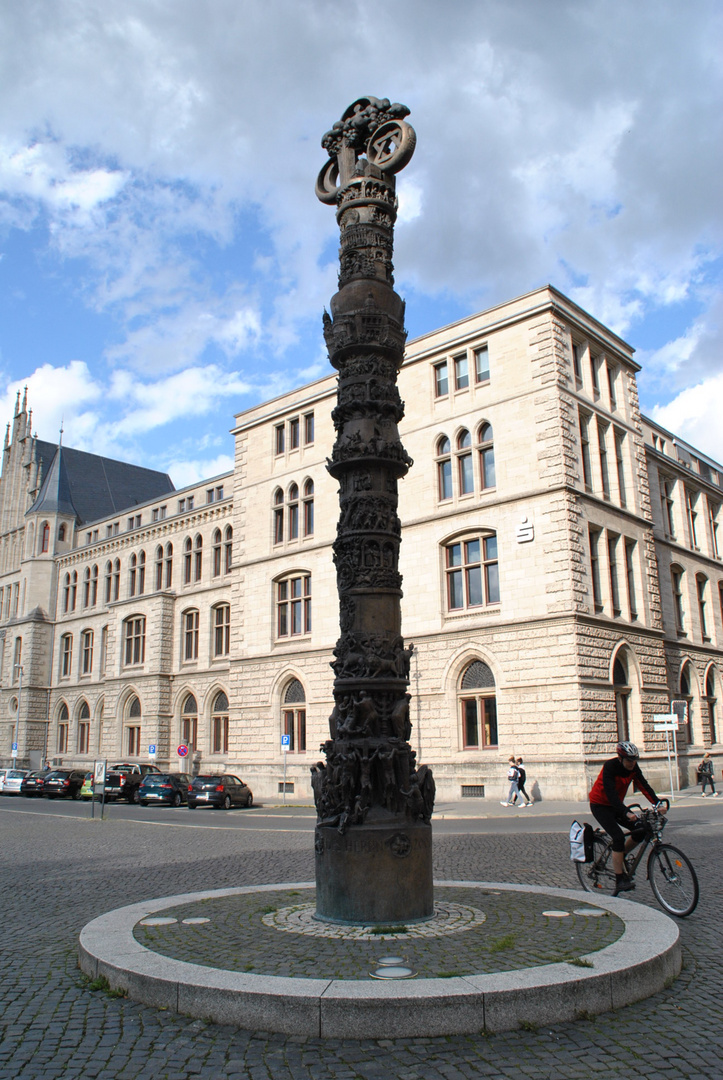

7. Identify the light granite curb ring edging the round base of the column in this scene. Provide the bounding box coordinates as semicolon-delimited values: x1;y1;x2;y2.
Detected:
79;881;682;1039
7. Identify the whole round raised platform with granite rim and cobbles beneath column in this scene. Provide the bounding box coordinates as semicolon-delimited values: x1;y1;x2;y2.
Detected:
79;881;681;1038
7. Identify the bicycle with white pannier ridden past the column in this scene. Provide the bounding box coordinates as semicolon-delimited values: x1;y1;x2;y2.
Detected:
575;806;700;919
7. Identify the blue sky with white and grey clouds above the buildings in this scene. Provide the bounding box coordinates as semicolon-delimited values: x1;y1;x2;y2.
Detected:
0;0;723;486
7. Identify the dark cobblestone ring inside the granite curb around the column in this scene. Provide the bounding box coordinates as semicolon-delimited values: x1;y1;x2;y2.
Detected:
134;888;624;978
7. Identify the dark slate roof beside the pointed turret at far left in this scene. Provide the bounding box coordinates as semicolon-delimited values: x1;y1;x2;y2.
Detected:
28;438;175;525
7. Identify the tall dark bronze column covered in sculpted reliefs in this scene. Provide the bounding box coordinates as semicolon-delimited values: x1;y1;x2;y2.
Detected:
311;97;434;923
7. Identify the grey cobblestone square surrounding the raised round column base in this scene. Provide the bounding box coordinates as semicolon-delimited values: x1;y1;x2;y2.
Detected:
0;806;723;1080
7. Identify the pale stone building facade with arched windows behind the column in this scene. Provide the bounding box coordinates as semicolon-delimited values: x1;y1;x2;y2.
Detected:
0;287;723;799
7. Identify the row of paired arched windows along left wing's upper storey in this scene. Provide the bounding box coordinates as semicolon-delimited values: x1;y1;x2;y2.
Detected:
63;525;233;615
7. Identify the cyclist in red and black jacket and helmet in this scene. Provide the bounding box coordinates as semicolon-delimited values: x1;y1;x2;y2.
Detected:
590;742;660;896
